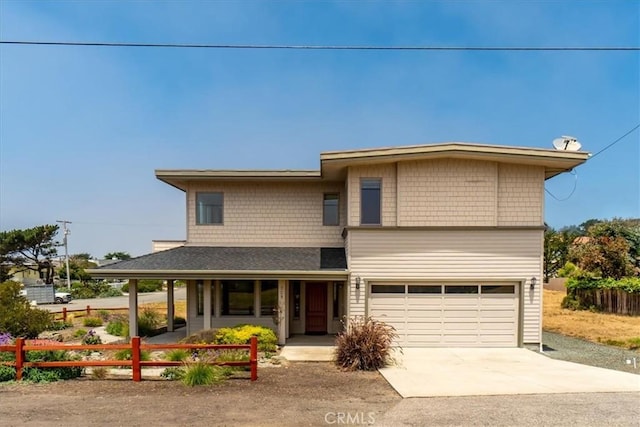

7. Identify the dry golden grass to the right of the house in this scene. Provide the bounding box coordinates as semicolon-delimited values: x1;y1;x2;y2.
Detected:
542;289;640;348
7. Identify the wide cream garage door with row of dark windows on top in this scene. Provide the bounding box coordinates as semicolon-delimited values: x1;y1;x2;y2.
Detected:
369;283;518;347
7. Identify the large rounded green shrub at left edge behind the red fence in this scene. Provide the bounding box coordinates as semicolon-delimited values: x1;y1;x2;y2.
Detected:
0;282;53;338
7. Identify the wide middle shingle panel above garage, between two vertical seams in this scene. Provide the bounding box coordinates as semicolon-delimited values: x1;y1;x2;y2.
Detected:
398;159;497;226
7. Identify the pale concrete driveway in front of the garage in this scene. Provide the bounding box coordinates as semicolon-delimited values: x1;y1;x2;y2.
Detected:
380;348;640;397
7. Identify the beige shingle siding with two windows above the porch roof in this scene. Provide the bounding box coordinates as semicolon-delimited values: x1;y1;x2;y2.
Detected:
187;182;347;247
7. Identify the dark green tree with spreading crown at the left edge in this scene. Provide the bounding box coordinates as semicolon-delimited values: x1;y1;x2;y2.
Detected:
0;225;60;283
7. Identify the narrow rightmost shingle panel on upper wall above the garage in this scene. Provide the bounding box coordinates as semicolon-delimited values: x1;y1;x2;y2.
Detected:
498;163;544;226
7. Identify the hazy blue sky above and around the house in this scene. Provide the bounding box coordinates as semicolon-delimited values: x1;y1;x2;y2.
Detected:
0;0;640;257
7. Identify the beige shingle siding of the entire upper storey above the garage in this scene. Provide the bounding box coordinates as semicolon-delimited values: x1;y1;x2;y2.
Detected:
348;158;544;227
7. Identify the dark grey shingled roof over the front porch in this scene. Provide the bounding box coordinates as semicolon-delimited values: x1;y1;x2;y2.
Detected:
87;246;348;279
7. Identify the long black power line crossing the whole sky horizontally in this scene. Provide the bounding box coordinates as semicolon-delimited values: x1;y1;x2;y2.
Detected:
0;40;640;52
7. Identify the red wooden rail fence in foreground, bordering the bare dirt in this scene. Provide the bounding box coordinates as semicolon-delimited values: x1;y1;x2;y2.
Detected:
0;337;258;382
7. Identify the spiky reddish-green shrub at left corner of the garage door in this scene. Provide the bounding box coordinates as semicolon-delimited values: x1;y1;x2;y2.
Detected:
335;316;398;371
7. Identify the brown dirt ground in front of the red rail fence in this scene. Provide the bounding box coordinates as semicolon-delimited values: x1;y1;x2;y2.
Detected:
0;363;402;426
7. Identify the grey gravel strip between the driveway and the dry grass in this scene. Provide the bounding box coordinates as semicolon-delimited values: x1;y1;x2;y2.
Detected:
542;332;640;374
